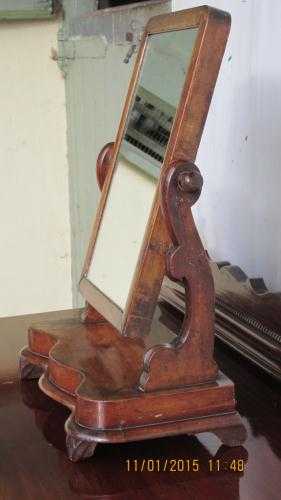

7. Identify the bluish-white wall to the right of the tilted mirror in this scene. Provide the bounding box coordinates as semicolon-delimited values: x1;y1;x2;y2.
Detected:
174;0;281;290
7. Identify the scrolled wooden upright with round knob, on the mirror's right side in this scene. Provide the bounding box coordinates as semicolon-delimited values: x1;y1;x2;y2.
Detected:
140;162;217;391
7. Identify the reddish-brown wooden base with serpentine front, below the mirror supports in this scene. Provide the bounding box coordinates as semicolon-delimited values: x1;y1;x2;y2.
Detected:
20;315;246;461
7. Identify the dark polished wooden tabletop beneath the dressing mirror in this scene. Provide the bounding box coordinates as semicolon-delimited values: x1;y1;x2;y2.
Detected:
0;313;281;500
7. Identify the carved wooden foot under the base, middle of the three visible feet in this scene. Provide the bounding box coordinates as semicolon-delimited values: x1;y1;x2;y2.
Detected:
65;416;97;462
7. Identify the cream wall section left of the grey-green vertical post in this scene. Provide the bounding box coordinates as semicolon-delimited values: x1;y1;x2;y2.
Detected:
0;21;72;316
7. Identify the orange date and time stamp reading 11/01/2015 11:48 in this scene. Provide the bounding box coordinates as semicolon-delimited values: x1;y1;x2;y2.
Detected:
126;458;246;473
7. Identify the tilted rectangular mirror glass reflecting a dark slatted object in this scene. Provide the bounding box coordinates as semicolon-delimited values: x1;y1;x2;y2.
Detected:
87;28;198;310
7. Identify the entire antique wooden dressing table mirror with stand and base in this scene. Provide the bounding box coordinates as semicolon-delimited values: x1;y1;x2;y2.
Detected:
20;6;245;461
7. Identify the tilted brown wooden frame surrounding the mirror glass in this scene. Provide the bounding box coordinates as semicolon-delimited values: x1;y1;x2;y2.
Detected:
79;6;230;336
